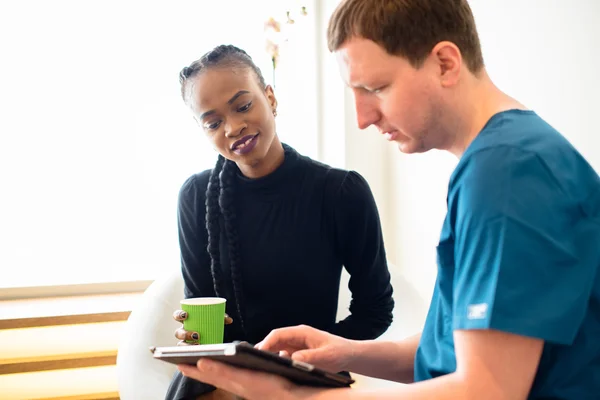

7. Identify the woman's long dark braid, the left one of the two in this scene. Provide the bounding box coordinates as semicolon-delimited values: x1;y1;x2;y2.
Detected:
206;156;225;297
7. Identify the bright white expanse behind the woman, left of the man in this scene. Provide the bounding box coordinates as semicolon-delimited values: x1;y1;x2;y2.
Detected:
0;0;326;288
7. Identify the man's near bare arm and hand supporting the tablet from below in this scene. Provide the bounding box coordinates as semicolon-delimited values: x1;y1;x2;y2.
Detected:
179;330;543;400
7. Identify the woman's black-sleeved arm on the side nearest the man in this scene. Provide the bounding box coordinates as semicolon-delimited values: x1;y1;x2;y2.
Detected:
332;171;394;340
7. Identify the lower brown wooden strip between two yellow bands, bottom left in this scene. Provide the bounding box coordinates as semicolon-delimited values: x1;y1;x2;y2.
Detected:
0;350;117;375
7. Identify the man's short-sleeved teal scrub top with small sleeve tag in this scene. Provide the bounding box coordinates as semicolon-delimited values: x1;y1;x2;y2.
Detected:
415;110;600;400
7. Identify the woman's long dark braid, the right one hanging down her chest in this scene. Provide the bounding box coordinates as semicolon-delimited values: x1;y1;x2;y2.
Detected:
219;161;245;331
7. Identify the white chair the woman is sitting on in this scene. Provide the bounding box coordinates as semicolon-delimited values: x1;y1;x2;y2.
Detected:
117;265;428;400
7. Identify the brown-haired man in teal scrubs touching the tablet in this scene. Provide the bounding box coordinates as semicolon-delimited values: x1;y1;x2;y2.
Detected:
181;0;600;400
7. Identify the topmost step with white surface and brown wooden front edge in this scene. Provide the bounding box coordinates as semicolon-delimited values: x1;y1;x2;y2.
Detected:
0;293;142;330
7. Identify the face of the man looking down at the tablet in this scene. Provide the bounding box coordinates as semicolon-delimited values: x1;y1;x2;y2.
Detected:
335;38;442;153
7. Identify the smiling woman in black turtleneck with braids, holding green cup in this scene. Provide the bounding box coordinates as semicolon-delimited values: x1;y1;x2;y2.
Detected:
167;45;394;399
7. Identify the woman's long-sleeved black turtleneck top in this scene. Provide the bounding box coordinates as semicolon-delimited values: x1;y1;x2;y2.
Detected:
167;145;394;399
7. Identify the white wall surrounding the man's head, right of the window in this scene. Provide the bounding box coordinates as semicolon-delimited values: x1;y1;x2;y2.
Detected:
321;0;600;304
